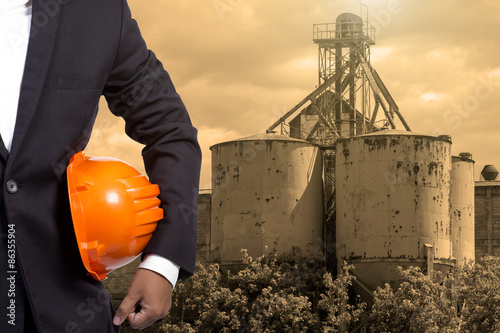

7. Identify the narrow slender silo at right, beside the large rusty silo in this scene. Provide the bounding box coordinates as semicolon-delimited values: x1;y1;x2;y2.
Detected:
451;154;475;265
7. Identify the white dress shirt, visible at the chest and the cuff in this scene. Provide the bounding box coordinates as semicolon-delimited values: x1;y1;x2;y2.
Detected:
0;0;180;288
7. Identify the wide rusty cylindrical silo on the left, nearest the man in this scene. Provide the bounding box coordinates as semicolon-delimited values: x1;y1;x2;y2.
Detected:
211;134;323;265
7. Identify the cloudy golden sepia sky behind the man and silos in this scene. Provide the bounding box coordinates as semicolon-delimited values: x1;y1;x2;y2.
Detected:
87;0;500;188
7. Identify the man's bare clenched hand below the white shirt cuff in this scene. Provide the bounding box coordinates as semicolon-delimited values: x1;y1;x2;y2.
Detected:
113;268;172;329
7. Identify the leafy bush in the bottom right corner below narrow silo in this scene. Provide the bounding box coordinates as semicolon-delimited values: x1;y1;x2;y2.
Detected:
369;257;500;333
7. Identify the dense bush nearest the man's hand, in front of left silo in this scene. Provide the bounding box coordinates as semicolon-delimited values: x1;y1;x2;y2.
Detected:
162;250;364;332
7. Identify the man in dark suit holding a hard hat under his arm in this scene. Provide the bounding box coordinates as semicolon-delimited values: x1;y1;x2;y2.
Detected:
0;0;201;332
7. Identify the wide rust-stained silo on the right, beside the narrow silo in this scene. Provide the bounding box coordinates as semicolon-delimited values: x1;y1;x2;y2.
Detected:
335;130;452;290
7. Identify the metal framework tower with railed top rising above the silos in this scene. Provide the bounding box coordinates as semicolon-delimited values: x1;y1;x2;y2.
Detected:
267;13;410;141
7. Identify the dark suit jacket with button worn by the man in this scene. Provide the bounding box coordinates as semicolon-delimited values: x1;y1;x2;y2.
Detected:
0;0;201;332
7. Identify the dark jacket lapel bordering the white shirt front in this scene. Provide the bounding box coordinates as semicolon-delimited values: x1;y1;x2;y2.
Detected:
7;0;64;169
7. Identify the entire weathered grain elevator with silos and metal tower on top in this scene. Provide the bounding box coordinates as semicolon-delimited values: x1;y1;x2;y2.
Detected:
205;13;475;312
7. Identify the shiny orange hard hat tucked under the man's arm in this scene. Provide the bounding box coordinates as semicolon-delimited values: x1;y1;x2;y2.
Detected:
67;151;163;281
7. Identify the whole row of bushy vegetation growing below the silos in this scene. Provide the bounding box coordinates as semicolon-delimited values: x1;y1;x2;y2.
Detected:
130;252;500;333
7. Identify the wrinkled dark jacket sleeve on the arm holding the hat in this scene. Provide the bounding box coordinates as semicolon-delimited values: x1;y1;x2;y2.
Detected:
104;0;201;279
